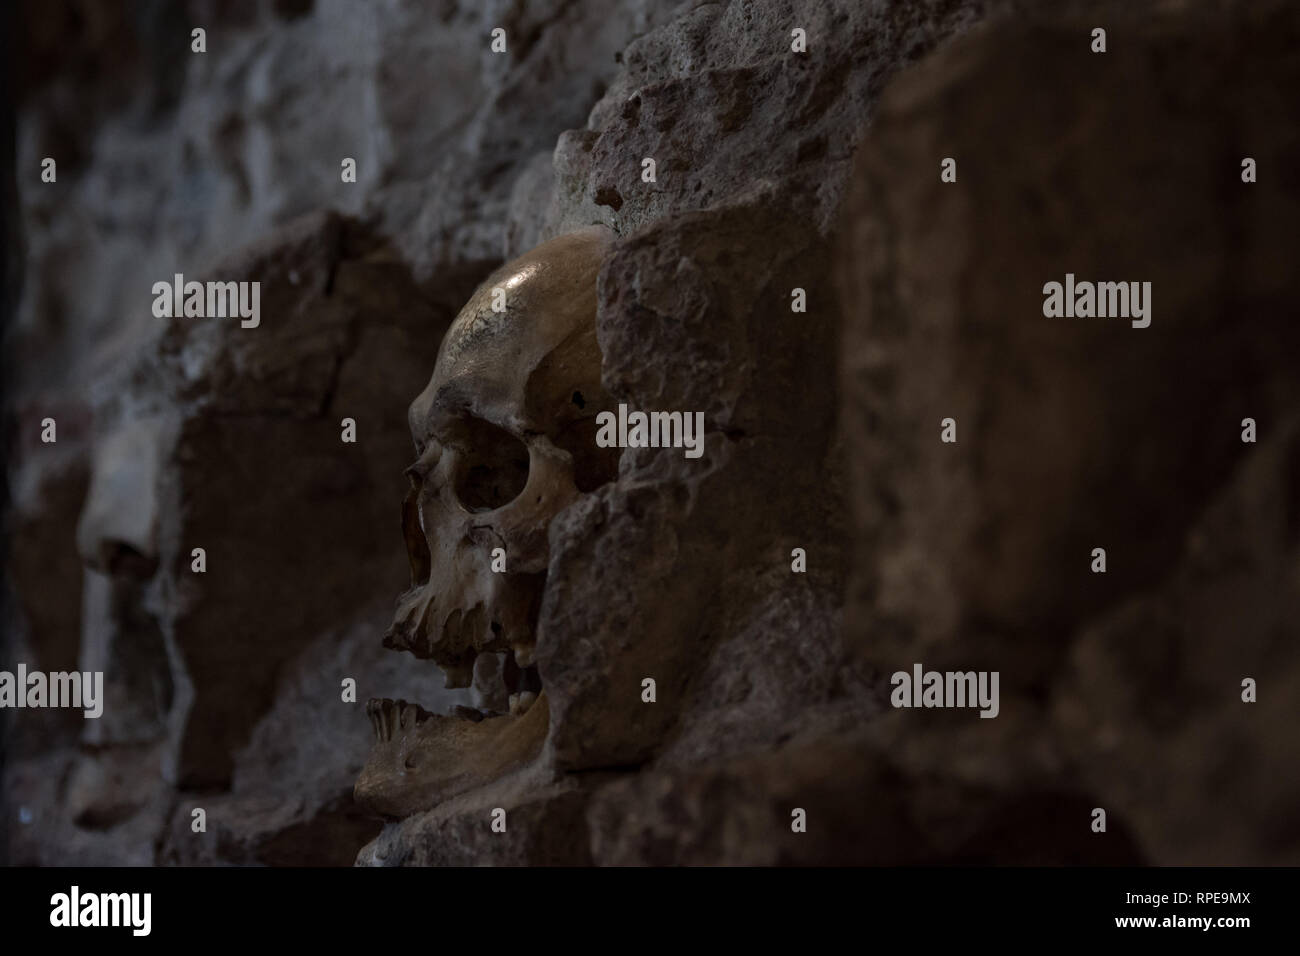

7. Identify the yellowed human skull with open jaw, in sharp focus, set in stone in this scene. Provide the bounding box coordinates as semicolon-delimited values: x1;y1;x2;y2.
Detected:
356;226;619;817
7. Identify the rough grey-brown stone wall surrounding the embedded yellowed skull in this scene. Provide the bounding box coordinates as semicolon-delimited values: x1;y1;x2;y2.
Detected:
0;0;1300;865
